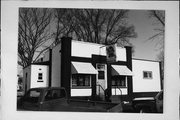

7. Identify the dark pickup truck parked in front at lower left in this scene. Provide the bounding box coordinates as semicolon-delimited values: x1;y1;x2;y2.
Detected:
17;87;122;112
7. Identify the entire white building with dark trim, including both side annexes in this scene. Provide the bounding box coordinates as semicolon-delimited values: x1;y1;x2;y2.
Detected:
23;37;161;101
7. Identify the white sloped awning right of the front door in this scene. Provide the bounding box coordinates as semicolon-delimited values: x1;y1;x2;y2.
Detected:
112;65;133;76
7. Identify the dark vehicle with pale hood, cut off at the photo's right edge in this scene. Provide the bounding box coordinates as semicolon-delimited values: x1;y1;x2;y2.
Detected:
132;91;163;113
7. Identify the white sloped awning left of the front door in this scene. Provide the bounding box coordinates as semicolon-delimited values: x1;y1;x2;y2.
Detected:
71;62;98;74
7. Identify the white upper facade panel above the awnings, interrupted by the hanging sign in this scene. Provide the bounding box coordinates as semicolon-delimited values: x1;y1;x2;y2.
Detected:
71;41;126;61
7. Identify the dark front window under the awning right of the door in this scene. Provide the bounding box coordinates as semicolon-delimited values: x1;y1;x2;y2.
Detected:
112;76;127;87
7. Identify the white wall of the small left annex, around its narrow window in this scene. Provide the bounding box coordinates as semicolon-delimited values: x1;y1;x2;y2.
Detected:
30;65;49;88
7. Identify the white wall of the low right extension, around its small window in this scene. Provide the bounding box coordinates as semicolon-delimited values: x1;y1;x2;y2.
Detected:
132;59;161;92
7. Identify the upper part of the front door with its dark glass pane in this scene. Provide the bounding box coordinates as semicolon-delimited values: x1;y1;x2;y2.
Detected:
96;64;105;80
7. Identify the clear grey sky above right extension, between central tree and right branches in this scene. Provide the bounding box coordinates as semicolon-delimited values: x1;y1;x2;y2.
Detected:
129;10;162;60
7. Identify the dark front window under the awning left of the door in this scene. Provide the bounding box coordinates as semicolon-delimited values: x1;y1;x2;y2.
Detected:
72;74;91;88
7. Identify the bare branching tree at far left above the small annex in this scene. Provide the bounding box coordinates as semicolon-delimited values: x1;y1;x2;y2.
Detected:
18;8;52;67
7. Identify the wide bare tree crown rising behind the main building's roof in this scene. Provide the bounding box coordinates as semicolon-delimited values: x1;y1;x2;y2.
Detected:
53;9;136;45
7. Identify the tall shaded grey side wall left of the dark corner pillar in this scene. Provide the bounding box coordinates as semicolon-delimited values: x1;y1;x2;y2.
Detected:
51;44;61;87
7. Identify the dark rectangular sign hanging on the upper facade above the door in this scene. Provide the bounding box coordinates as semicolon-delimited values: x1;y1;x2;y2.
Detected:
106;45;116;62
